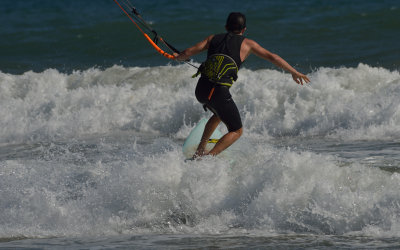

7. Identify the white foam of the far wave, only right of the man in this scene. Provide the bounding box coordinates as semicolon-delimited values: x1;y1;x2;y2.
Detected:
236;64;400;139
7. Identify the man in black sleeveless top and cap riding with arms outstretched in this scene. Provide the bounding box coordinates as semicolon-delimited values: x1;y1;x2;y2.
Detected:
175;12;310;159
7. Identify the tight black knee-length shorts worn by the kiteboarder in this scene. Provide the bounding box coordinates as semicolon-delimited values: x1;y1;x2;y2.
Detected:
195;77;242;132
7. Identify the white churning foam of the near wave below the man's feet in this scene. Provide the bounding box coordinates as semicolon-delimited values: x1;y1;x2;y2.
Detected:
0;138;400;237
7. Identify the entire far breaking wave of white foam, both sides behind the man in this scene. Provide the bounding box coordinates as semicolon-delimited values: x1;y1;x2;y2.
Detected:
0;64;400;142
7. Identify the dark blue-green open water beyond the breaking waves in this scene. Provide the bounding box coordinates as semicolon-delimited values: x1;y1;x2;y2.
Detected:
0;0;400;74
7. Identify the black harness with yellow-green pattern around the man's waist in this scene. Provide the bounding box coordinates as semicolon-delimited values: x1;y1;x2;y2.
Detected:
192;54;239;100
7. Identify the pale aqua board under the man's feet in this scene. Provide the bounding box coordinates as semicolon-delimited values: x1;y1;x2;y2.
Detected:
182;118;223;159
